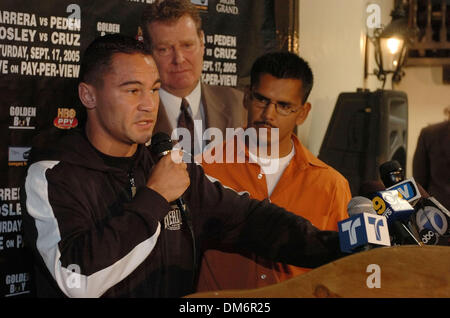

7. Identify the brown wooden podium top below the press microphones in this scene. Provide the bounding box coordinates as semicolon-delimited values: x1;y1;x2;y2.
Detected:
186;245;450;298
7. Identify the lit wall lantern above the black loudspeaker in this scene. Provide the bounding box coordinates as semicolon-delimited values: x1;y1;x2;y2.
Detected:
365;5;414;88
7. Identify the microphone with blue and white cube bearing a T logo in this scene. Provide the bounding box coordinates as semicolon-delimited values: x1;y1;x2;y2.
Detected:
338;196;391;253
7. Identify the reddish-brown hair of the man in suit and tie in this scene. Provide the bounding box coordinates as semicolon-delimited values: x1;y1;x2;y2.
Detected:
141;0;202;48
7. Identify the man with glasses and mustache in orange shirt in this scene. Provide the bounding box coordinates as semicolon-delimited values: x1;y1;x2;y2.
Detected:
197;52;351;291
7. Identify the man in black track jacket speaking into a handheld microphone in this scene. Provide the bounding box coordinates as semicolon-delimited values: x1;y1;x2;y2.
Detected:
21;34;342;297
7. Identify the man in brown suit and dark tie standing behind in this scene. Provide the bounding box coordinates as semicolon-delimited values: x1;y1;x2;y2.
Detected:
142;0;246;154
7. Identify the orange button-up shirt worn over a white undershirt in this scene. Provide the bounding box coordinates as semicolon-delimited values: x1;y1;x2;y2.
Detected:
197;135;351;291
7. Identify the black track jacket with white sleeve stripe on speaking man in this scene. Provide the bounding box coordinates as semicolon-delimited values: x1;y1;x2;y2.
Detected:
21;130;342;297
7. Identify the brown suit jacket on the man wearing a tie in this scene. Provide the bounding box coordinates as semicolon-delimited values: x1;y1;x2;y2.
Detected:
153;83;247;138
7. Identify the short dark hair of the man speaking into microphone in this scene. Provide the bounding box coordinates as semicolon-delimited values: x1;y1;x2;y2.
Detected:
78;34;151;85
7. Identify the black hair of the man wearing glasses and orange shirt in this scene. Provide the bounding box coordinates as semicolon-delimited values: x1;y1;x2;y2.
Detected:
250;52;314;103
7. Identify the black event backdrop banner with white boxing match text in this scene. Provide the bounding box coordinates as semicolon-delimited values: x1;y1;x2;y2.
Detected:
0;0;276;297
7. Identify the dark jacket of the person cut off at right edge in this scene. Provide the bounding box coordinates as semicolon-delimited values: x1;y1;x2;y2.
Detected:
413;121;450;210
